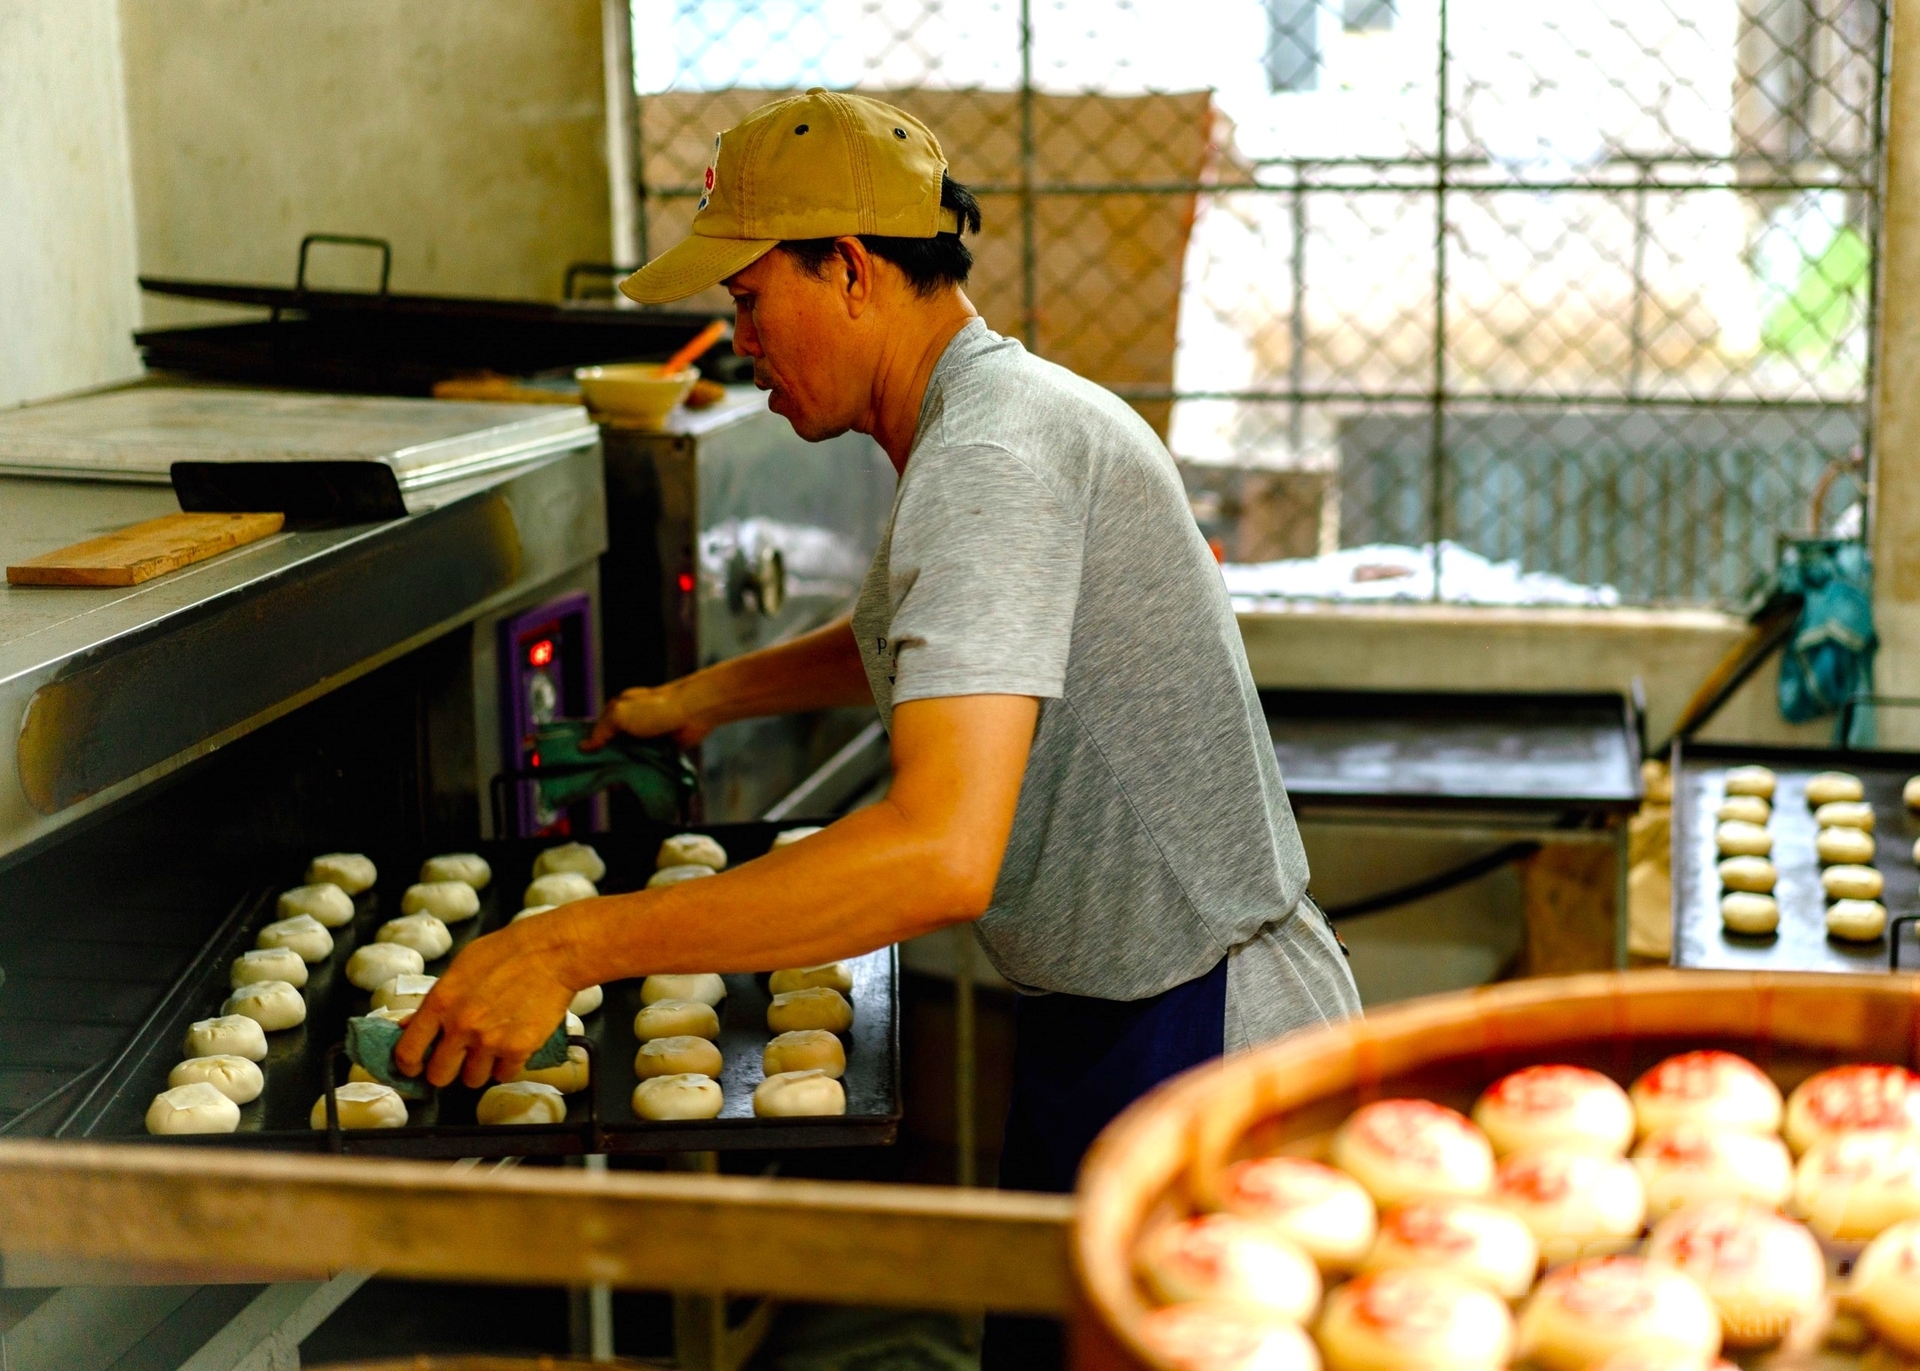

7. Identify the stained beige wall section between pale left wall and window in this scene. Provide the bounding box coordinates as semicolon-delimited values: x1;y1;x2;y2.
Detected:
120;0;609;323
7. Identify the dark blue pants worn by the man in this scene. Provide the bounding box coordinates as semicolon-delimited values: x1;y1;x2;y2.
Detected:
981;958;1227;1371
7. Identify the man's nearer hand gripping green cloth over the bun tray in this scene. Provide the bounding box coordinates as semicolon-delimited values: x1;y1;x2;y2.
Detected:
394;914;576;1091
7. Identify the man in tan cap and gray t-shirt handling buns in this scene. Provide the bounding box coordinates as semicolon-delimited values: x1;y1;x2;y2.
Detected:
396;90;1357;1267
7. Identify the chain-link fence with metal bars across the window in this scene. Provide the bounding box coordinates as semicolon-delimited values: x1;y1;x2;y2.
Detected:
634;0;1885;605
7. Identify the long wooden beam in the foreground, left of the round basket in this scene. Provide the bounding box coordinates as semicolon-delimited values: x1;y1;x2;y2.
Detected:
0;1141;1073;1315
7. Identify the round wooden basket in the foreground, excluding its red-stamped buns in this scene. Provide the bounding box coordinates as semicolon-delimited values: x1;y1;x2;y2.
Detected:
1073;970;1920;1371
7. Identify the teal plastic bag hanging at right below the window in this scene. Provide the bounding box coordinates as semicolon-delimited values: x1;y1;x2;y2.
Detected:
1778;538;1880;747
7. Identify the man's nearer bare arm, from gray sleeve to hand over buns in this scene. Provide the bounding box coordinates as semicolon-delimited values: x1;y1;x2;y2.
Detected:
397;695;1041;1087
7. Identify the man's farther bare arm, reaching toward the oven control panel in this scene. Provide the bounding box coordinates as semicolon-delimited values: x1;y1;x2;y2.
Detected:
586;616;874;749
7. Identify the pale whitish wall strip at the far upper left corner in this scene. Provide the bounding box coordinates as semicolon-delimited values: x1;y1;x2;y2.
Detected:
0;0;140;405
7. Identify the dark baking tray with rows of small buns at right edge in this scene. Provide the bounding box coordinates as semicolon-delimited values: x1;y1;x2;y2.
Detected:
1672;741;1920;972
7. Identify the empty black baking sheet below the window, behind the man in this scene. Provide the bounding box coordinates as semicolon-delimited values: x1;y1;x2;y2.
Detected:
1260;689;1640;816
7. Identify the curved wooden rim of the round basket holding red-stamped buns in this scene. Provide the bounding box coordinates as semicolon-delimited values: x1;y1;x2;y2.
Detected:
1069;968;1920;1367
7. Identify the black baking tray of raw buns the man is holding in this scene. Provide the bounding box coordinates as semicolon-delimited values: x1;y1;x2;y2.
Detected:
54;822;900;1158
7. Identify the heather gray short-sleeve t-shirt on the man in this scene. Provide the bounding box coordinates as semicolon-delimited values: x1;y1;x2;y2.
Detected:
852;321;1359;1048
